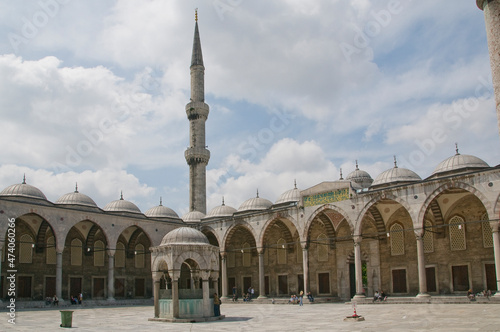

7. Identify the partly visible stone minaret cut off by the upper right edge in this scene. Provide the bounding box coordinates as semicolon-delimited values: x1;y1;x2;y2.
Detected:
476;0;500;136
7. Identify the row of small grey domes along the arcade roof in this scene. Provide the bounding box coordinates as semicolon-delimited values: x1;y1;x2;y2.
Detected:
0;149;490;223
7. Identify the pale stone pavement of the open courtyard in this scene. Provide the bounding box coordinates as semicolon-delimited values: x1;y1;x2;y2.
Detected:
0;303;500;332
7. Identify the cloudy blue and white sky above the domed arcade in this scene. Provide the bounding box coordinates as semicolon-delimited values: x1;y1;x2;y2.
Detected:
0;0;500;215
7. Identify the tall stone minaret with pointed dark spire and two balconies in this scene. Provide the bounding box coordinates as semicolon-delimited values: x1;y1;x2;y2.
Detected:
184;12;210;214
